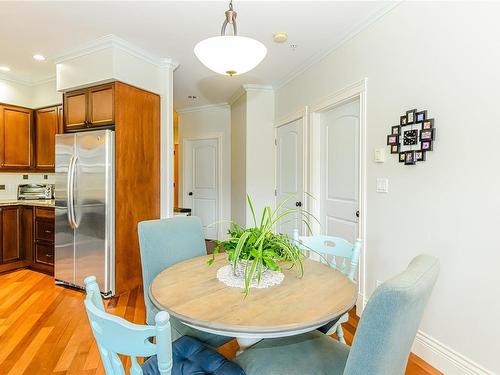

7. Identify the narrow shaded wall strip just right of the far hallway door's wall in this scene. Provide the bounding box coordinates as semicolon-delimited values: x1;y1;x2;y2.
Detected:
231;93;247;225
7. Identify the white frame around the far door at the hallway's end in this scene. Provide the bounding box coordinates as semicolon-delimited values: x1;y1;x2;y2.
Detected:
181;137;223;240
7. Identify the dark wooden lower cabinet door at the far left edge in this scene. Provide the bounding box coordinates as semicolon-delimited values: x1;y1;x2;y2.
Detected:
1;207;21;263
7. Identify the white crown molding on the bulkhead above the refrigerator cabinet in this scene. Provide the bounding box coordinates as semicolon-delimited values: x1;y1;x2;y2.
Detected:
52;34;179;70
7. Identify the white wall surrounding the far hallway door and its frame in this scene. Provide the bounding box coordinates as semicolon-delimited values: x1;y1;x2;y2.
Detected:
178;105;231;238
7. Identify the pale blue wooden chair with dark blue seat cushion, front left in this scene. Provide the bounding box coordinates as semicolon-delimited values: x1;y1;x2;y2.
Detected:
85;276;245;375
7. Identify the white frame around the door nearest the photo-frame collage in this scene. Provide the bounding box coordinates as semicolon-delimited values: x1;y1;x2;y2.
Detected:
308;78;368;315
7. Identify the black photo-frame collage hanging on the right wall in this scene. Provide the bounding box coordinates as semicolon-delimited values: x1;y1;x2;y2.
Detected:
387;109;436;165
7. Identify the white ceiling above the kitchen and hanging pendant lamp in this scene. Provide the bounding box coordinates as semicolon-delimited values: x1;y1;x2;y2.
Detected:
0;0;394;108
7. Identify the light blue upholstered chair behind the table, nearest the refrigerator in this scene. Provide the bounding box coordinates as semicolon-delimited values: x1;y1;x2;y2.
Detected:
139;216;231;348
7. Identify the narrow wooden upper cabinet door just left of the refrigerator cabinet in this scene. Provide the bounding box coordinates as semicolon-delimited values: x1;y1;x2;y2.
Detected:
35;107;59;169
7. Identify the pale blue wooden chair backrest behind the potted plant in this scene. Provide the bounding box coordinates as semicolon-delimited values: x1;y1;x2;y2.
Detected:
293;229;363;280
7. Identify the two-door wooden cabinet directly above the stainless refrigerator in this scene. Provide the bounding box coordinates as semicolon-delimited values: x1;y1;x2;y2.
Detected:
64;83;115;132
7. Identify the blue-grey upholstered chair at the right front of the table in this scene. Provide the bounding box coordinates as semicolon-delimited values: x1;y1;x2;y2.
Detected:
235;255;439;375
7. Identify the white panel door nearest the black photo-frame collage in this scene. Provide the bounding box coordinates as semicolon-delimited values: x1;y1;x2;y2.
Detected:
320;100;360;243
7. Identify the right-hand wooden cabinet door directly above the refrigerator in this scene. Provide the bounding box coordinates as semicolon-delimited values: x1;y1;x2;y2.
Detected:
89;84;115;127
